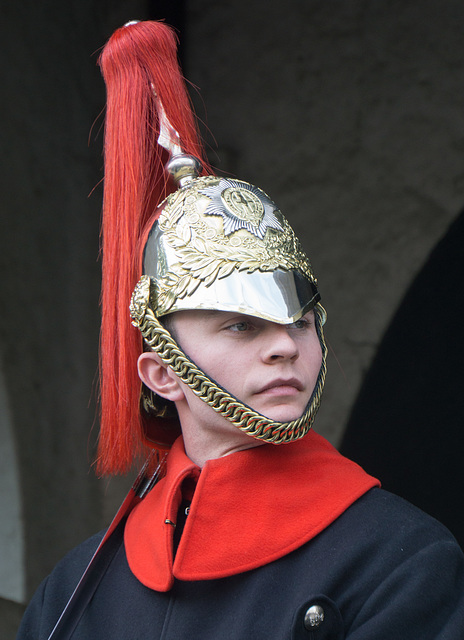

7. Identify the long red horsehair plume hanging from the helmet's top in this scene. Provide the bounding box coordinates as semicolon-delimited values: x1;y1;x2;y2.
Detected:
97;22;206;475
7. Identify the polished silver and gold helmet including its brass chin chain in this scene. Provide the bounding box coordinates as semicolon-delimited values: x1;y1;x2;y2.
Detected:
130;155;327;444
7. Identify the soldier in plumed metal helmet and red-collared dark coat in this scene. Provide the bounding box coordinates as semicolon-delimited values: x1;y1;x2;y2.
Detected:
18;22;464;640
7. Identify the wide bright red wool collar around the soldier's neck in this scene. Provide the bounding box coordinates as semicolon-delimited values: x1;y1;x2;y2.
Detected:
124;431;379;591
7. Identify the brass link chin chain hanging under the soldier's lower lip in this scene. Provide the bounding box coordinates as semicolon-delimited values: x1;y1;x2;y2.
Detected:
131;276;327;444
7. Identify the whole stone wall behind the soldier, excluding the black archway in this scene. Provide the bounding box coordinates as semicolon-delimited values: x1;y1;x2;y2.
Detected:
0;0;464;639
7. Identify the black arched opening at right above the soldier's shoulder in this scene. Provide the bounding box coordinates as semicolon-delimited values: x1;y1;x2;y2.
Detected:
341;212;464;545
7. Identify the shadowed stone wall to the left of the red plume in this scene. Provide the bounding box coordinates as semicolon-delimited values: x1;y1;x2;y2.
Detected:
0;0;151;638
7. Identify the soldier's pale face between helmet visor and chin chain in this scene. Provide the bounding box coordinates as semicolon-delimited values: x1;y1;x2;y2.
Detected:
168;311;322;428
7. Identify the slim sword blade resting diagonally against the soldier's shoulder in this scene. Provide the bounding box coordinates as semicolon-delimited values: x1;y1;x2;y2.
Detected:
48;451;167;640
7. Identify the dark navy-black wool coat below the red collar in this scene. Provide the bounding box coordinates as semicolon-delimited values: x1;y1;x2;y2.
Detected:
18;489;464;640
